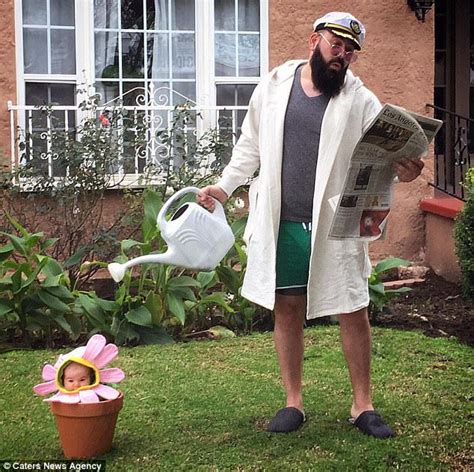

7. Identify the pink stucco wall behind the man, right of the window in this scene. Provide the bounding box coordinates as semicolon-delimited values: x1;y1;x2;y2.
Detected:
269;0;434;262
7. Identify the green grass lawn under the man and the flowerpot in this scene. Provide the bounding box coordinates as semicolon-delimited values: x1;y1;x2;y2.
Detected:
0;326;474;472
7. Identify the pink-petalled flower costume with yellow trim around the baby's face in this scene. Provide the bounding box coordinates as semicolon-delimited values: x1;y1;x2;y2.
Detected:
33;334;125;403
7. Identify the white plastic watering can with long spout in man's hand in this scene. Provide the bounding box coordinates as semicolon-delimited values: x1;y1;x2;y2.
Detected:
108;187;235;282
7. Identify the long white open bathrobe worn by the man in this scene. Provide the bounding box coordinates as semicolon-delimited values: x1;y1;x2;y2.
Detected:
218;61;381;318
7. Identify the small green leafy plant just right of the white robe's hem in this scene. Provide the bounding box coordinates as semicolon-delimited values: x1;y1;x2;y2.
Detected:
369;257;411;319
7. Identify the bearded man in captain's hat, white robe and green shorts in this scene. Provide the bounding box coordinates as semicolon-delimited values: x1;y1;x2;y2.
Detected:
198;12;423;439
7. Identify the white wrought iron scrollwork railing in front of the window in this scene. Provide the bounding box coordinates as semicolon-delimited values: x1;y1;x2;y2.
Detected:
8;88;248;185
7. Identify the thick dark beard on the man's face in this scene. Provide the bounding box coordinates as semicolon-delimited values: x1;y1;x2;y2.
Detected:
309;44;348;97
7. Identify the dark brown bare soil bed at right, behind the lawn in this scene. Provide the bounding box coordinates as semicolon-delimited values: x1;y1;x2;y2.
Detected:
373;272;474;346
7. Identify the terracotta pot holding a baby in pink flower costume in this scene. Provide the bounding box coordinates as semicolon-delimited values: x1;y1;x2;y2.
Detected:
33;334;125;459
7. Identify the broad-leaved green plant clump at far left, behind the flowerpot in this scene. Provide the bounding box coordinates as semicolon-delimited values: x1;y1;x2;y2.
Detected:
0;214;81;344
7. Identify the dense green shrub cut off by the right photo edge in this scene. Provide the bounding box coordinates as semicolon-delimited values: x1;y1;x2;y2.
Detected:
454;167;474;299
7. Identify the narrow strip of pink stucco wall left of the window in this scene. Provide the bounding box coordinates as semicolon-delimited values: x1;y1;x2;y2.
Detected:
0;0;16;167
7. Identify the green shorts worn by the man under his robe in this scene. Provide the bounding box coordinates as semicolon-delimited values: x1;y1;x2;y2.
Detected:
276;221;311;295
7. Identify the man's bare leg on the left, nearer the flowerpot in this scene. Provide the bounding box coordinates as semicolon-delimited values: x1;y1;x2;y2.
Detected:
273;294;306;411
